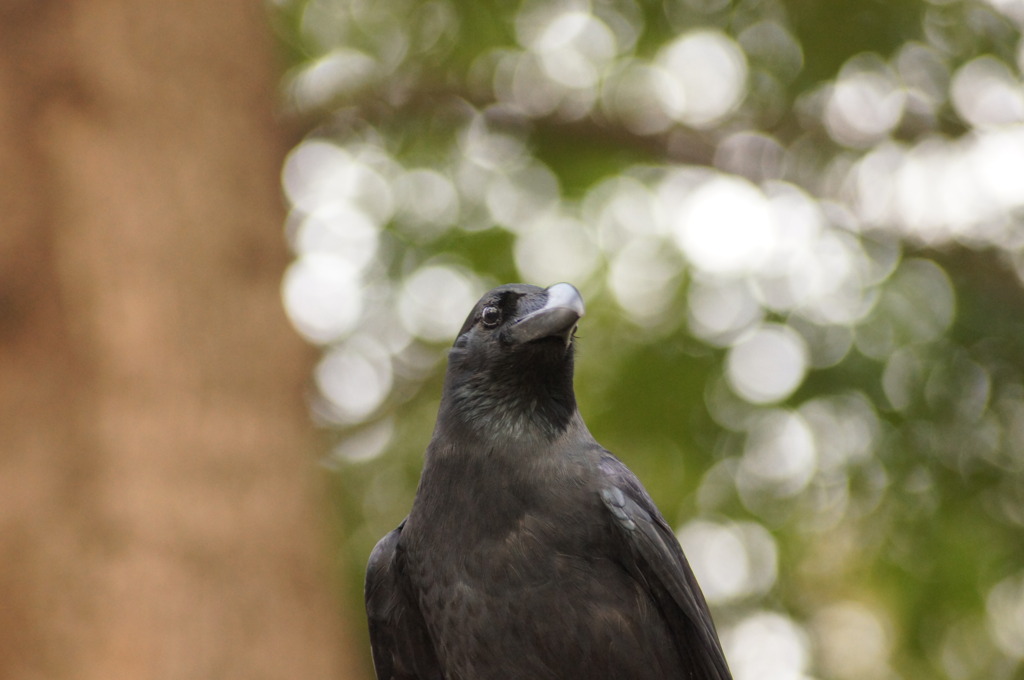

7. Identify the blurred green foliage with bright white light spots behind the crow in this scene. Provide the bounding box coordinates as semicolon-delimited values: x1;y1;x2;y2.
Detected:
271;0;1024;680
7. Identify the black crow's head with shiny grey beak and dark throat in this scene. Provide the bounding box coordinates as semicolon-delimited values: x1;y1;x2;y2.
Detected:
440;284;584;440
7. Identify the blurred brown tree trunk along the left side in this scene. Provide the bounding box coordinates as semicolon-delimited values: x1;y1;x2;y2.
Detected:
0;0;360;680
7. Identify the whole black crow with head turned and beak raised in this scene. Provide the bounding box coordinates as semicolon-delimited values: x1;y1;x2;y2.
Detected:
366;284;731;680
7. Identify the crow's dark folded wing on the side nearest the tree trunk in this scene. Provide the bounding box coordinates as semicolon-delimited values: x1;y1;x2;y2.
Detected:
366;521;443;680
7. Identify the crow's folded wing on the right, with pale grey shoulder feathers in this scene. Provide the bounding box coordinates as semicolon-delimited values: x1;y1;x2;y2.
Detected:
601;455;732;680
